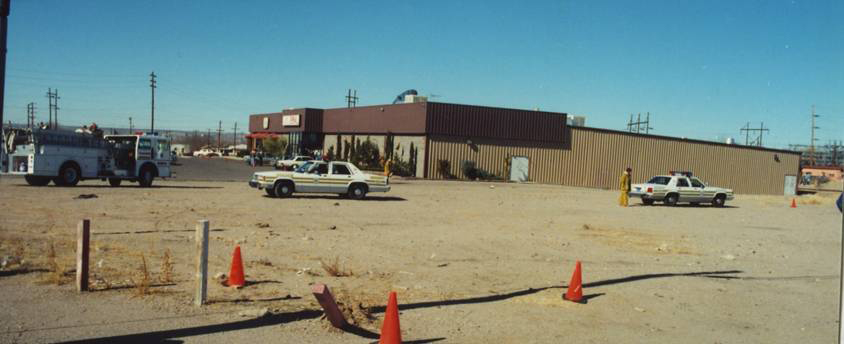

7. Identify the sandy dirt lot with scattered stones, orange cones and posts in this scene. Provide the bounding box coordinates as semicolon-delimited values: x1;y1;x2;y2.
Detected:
0;165;841;343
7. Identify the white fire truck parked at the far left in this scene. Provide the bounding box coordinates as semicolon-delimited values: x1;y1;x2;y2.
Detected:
0;128;171;187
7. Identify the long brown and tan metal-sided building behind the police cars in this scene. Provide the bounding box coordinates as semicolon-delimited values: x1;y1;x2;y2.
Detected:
247;102;800;195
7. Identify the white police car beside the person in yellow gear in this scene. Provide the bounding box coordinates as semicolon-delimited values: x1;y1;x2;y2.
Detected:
628;171;734;207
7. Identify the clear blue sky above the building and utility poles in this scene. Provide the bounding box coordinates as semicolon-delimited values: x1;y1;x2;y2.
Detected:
5;0;844;148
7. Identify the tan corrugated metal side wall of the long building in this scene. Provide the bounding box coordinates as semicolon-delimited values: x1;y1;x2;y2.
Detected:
426;127;800;195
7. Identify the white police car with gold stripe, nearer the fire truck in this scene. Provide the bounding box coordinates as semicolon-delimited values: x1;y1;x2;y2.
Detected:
249;160;390;199
